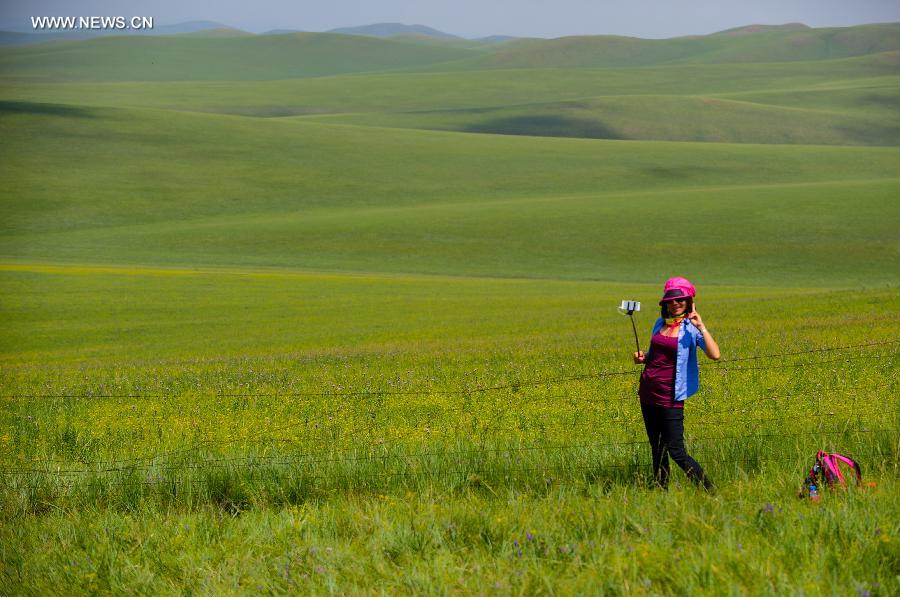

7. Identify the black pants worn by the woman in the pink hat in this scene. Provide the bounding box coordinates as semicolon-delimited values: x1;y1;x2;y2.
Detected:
641;403;713;489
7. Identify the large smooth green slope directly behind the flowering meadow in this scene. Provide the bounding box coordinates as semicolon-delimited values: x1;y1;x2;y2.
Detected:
0;104;900;287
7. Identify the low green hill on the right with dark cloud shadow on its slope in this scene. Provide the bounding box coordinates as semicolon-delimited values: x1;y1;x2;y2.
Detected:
308;87;900;145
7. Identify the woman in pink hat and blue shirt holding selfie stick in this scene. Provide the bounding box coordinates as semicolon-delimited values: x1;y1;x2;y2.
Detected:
634;278;720;490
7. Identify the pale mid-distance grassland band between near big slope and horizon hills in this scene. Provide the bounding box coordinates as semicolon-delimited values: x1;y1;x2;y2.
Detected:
0;52;900;145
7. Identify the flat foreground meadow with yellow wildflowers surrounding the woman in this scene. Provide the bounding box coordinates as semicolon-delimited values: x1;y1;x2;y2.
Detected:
0;266;900;593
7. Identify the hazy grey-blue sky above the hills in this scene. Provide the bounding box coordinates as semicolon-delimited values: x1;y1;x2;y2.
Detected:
0;0;900;37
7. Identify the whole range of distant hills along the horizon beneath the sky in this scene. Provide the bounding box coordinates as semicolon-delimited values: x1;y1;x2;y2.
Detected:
0;22;900;81
